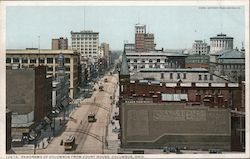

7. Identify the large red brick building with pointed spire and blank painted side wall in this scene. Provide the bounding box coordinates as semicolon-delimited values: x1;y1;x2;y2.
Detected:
119;53;243;151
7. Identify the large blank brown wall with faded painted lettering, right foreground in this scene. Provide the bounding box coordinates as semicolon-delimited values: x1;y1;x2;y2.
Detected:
120;100;231;151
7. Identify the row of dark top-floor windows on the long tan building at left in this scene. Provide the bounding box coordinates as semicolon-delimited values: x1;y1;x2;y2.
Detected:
6;57;70;64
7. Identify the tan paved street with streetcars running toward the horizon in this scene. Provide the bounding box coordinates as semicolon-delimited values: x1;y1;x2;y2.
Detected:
37;74;118;154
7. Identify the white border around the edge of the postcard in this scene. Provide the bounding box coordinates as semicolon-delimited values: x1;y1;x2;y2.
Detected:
0;0;250;158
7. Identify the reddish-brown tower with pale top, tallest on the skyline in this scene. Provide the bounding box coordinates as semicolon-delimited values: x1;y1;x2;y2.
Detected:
135;24;155;52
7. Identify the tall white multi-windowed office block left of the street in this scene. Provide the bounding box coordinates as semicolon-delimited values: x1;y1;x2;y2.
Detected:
71;30;99;60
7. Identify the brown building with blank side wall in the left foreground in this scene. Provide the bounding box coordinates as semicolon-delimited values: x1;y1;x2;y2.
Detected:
6;66;52;141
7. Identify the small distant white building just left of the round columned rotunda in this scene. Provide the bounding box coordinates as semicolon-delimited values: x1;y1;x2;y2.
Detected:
192;40;209;55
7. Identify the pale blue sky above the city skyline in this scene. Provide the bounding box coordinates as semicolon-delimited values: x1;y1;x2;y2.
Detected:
6;6;245;50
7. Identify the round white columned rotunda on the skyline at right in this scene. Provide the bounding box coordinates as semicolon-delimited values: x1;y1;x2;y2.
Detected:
210;33;234;54
